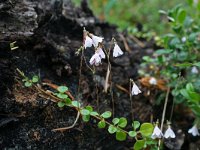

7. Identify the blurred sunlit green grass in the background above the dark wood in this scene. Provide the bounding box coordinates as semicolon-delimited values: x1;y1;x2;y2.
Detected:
73;0;196;35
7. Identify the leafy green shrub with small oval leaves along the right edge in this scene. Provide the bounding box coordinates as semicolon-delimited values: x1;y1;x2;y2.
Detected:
139;1;200;125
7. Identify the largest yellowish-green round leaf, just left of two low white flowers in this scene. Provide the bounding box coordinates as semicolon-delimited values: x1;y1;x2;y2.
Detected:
140;123;153;137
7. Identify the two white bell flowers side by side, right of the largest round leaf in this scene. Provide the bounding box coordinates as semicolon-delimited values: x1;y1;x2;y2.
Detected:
151;122;176;139
